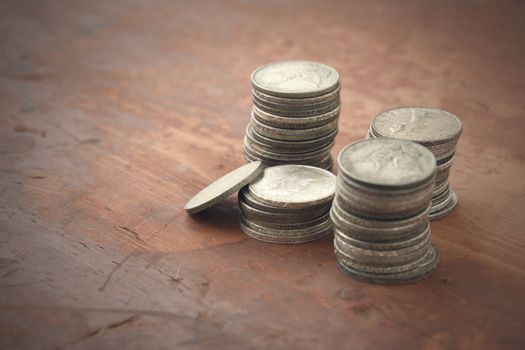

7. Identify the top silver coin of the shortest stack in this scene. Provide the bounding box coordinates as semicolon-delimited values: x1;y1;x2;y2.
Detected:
248;165;336;208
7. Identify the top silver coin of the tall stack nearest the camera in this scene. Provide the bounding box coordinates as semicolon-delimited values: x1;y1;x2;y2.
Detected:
338;138;436;188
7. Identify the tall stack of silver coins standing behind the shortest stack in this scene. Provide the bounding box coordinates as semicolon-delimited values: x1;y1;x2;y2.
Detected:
244;61;341;169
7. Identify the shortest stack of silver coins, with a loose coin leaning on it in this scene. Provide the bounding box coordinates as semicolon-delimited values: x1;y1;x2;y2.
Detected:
239;165;336;243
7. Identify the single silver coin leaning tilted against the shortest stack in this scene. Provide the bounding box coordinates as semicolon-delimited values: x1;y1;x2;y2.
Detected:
184;162;264;214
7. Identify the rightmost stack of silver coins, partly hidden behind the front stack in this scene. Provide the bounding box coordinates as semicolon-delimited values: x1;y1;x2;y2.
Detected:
368;107;463;220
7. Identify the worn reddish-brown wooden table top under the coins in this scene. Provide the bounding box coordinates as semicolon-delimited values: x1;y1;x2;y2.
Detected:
0;0;525;349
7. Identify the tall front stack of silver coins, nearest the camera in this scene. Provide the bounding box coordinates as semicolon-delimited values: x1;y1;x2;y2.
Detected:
330;138;439;284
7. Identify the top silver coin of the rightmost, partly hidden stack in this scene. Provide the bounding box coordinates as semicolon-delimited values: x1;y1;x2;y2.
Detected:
372;107;463;144
